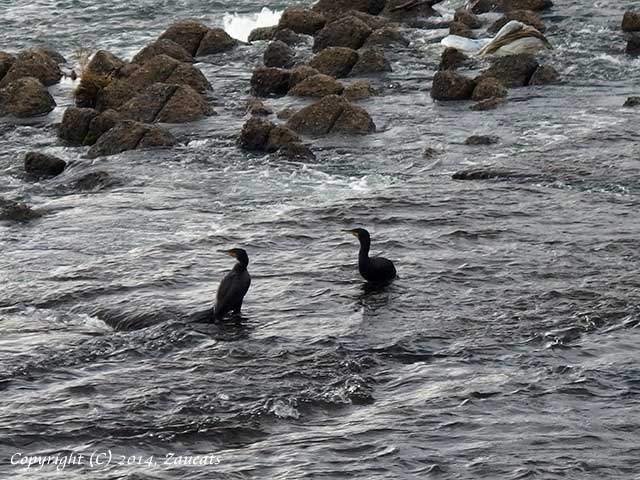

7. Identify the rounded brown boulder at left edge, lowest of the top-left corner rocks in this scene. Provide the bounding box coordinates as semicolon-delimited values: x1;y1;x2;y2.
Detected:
0;77;56;118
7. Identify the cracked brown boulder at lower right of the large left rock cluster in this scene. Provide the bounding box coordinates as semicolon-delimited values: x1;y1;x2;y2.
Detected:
119;83;211;123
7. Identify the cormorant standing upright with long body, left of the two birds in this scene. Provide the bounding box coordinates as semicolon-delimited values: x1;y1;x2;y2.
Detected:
213;248;251;320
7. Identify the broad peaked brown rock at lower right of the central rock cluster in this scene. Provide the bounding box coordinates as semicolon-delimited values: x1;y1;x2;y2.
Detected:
287;95;375;135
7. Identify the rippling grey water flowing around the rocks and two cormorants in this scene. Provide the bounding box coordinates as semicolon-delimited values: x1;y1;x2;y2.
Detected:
0;0;640;480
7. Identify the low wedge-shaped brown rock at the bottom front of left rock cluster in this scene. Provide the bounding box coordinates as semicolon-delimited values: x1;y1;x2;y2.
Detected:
87;120;176;158
